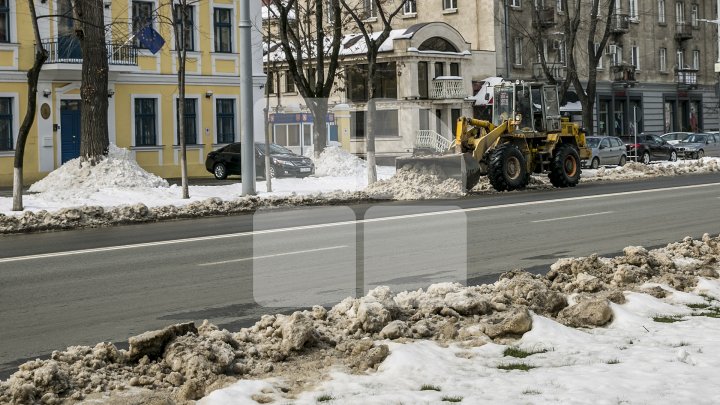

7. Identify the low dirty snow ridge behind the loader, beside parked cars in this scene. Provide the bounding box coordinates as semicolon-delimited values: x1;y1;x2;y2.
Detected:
582;158;720;181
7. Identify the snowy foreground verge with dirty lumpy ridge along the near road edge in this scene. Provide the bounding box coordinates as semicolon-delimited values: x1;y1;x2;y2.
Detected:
0;234;720;405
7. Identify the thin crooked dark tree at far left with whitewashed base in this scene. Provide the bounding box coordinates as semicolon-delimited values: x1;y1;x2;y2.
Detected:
13;0;48;211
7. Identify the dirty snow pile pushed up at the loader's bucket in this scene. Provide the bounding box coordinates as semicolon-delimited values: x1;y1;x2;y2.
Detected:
365;163;465;200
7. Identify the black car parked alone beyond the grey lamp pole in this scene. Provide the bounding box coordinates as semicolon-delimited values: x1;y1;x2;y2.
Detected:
205;142;315;180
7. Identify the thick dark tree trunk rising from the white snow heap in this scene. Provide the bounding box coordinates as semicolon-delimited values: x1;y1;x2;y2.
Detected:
74;0;110;165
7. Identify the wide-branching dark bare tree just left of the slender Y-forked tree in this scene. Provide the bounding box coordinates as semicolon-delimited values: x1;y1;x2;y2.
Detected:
269;0;344;158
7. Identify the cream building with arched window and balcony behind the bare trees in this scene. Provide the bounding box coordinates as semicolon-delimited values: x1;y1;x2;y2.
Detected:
265;0;496;162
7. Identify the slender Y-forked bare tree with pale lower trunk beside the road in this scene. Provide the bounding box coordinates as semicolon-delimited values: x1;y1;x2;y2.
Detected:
340;0;407;184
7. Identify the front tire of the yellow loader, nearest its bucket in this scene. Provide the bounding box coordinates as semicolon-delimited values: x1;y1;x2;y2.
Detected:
488;143;530;191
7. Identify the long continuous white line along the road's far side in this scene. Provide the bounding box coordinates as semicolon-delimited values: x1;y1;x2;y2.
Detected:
0;183;720;263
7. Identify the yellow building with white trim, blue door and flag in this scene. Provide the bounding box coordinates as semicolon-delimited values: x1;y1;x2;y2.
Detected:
0;0;265;185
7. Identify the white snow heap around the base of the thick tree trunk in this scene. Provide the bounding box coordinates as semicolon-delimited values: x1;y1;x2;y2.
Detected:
29;144;168;197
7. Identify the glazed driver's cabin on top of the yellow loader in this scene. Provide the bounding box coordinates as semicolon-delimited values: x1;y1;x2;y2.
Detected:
492;82;560;136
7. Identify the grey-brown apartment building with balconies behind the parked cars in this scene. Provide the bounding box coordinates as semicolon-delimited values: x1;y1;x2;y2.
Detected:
495;0;720;135
